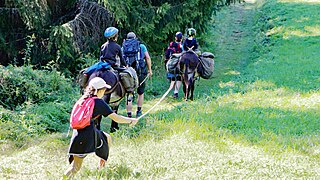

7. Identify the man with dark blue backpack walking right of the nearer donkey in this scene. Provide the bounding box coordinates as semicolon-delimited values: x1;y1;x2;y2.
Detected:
122;32;152;117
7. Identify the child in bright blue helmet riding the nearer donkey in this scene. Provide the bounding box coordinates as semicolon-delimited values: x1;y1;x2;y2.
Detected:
100;27;127;69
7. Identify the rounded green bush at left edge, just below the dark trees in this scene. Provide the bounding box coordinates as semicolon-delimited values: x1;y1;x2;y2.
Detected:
0;66;72;110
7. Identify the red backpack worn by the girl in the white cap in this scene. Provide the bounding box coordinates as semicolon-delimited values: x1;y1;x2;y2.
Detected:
70;97;98;129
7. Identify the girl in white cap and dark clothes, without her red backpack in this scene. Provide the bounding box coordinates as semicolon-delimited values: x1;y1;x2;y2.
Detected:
64;77;138;178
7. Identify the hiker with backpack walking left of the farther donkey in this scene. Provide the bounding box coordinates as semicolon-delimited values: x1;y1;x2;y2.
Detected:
164;32;183;98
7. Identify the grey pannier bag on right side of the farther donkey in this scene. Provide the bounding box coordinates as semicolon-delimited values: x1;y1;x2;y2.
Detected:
197;52;214;79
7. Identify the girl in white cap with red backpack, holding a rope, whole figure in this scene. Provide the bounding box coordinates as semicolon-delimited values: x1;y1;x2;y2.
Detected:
64;77;138;178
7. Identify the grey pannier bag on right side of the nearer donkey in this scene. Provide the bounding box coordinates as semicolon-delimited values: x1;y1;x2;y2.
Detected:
120;67;139;93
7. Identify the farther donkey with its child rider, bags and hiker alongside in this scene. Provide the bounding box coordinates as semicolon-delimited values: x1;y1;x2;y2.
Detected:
164;28;214;100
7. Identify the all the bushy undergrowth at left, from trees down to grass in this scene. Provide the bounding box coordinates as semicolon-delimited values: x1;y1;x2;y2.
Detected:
0;66;80;147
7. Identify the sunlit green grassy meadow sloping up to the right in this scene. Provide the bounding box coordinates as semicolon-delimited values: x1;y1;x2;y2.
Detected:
0;0;320;179
